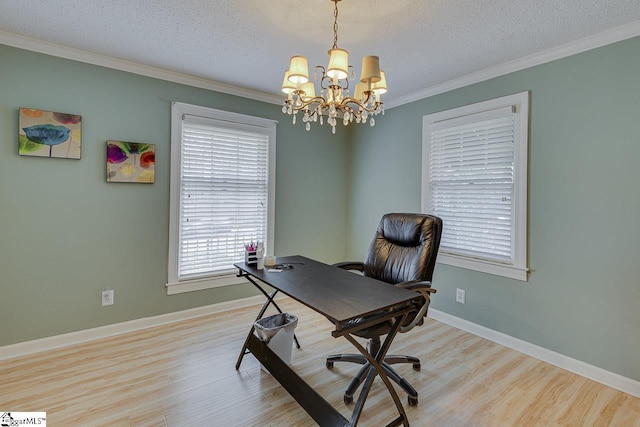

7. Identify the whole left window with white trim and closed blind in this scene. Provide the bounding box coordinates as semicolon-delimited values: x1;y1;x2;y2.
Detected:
167;103;276;294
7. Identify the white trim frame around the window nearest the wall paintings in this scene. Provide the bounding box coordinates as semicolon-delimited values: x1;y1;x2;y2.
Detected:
166;102;277;295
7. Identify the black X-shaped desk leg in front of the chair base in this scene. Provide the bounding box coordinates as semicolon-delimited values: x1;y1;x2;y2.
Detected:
344;314;409;427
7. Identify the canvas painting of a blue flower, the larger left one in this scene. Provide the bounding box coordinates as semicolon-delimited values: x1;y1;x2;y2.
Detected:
18;108;82;159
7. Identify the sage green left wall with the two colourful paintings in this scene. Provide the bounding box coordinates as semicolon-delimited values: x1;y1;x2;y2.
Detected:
0;45;347;346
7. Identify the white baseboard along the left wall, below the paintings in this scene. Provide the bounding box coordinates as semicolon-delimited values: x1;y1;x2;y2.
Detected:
0;295;265;360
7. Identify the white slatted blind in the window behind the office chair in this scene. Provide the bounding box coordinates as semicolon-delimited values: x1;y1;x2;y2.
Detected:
429;108;515;263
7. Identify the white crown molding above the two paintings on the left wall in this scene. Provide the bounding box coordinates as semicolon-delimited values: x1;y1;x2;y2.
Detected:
0;30;282;104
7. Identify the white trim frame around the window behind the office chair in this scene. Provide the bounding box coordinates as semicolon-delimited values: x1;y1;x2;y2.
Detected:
422;92;529;281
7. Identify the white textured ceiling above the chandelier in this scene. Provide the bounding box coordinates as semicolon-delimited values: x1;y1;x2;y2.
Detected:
0;0;640;102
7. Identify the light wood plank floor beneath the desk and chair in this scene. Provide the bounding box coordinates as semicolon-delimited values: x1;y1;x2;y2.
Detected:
0;300;640;427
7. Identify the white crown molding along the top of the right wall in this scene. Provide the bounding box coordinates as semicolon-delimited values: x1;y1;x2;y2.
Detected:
385;21;640;109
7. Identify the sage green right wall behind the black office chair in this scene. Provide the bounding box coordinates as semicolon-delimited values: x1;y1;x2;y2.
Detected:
348;38;640;380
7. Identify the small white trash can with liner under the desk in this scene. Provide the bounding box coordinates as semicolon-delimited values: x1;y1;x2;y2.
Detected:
254;313;298;372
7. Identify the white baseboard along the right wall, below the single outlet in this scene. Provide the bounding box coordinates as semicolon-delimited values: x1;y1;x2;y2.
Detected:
429;309;640;398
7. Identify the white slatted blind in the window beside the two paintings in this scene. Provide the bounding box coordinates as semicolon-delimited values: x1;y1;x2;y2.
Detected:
178;115;269;279
